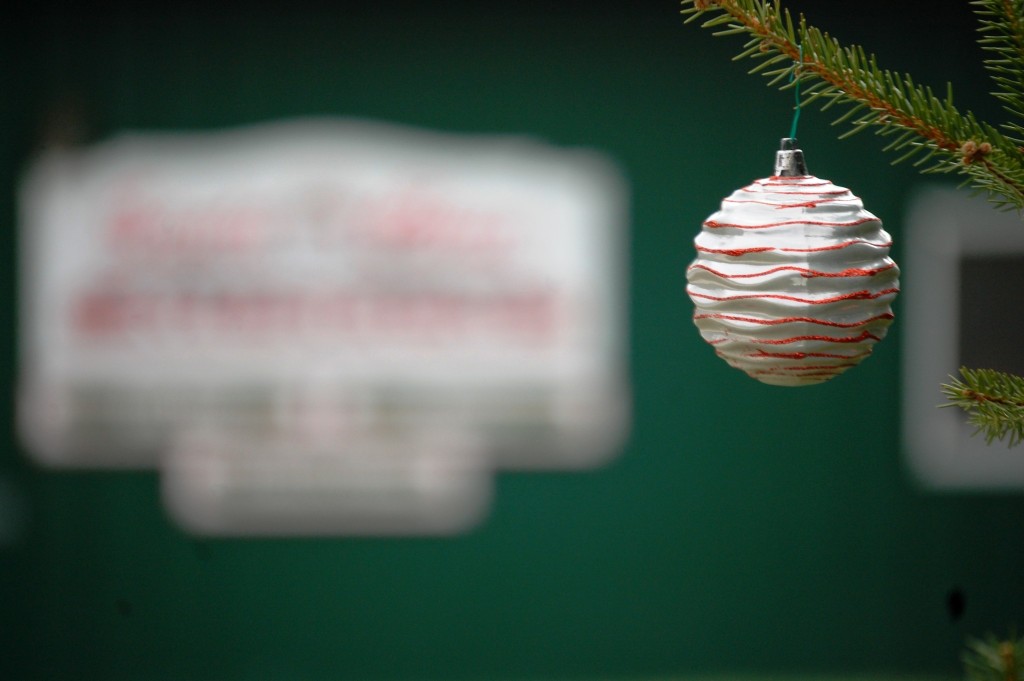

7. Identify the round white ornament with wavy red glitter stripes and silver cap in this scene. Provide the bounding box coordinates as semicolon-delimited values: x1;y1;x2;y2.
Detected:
686;137;899;386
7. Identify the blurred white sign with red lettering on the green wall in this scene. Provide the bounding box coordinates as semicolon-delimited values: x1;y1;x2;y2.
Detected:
20;115;629;533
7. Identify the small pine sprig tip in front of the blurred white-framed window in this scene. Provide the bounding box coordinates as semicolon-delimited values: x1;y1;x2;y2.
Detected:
942;368;1024;446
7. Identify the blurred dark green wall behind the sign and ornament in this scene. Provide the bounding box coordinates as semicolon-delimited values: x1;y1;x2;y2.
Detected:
0;0;1024;680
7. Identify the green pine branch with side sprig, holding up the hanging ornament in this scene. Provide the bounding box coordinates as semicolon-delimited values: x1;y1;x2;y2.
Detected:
682;0;1024;210
